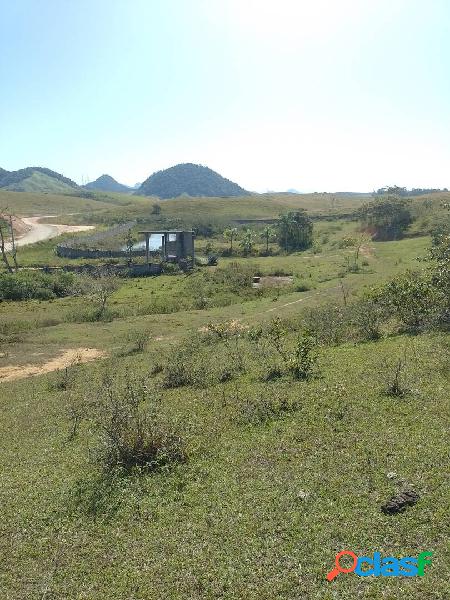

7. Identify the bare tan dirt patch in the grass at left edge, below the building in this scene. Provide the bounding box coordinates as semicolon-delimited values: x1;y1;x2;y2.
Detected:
0;348;106;383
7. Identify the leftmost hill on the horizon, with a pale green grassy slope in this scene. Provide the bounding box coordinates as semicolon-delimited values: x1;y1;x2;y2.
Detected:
0;167;78;194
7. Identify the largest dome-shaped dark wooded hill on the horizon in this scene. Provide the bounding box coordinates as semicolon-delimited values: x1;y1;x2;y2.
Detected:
135;163;250;198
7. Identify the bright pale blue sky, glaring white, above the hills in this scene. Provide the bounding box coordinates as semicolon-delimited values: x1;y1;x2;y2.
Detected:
0;0;450;192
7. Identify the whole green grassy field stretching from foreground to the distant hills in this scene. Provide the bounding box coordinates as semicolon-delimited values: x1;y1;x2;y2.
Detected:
0;193;450;600
